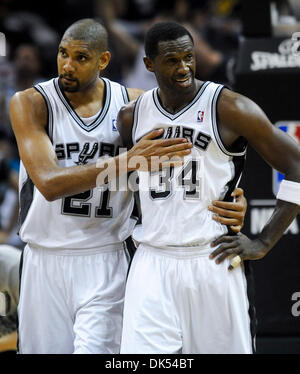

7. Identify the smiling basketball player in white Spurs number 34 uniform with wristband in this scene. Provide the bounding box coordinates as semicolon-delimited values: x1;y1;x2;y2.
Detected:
118;22;300;354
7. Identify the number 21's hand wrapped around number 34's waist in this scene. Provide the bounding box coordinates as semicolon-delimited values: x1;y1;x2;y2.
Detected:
208;188;247;233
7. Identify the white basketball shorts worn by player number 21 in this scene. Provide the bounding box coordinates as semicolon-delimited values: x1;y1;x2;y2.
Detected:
18;243;128;354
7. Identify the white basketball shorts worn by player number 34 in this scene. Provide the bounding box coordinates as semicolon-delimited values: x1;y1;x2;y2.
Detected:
121;244;252;354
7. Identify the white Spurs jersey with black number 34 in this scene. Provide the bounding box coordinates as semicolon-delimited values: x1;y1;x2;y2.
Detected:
133;82;245;247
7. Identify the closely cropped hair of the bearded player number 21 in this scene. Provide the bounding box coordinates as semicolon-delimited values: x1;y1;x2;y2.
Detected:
62;18;108;52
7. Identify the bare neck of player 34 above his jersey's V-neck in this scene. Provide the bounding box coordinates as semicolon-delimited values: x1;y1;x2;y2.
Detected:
158;79;203;114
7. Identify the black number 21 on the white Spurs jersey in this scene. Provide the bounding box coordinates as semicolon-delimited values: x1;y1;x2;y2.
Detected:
61;187;113;218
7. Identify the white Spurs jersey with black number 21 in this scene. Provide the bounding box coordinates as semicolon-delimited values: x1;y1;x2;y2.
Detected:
20;78;136;248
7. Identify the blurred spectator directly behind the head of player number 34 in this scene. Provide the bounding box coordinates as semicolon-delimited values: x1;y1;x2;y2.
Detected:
97;0;232;90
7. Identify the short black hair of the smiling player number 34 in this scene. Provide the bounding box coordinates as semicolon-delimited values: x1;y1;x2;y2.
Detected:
145;22;194;60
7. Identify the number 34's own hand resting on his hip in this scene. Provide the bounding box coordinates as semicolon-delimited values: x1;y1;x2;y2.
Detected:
209;233;268;270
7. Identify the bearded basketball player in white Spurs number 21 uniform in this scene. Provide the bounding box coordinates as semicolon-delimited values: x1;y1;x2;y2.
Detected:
10;19;244;353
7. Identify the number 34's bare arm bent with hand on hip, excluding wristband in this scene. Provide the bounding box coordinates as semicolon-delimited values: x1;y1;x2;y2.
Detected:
211;89;300;263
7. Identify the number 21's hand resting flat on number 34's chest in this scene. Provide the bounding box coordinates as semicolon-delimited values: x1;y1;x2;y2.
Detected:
128;129;193;171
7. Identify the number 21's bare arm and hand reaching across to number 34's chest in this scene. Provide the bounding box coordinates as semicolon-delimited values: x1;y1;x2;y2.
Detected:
10;88;190;201
